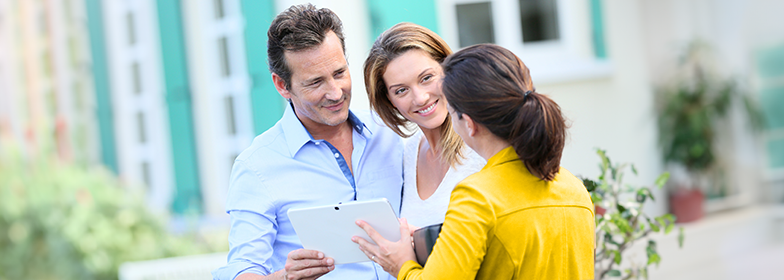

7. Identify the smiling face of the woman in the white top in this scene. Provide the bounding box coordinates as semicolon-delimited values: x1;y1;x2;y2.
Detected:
383;49;448;129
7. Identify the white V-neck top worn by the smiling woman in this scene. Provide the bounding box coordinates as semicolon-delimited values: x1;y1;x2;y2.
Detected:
400;130;487;227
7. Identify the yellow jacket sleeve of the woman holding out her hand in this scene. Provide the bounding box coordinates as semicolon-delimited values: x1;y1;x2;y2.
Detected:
398;184;495;280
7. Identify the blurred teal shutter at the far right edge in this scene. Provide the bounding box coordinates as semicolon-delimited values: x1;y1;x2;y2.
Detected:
755;45;784;168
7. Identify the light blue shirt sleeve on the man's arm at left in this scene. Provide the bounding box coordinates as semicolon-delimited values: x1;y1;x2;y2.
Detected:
213;161;278;280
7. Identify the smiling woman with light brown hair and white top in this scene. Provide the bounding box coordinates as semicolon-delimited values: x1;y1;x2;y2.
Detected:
364;22;485;227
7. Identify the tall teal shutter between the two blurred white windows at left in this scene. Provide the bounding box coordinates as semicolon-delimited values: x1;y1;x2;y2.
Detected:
157;0;202;214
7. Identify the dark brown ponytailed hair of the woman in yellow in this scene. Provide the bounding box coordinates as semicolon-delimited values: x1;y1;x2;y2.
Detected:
443;44;566;181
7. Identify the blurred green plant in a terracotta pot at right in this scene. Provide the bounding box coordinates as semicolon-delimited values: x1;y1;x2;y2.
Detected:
656;41;762;222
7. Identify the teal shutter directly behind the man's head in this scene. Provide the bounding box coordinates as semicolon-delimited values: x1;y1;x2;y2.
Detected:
242;0;285;134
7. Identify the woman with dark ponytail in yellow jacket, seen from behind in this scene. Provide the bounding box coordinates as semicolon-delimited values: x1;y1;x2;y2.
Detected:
353;44;594;279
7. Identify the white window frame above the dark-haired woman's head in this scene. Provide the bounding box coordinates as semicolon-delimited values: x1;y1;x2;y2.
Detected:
438;0;612;84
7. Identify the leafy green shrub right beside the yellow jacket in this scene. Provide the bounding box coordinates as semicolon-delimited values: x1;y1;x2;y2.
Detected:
583;149;683;279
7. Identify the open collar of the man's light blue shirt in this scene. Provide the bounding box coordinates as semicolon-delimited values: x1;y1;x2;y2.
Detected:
280;103;372;157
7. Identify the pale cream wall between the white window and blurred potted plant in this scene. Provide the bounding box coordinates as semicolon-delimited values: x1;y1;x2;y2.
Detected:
544;1;666;215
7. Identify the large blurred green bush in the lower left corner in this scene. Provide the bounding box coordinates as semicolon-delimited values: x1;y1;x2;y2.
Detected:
0;143;226;279
